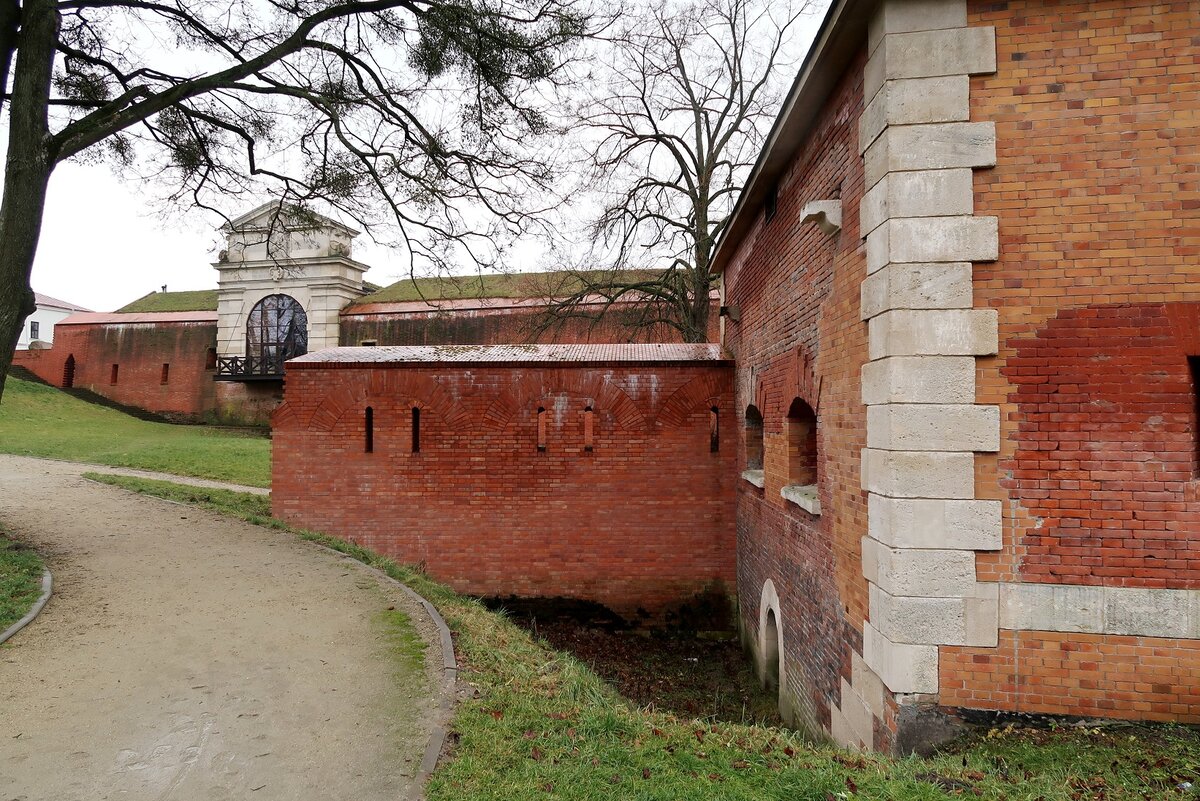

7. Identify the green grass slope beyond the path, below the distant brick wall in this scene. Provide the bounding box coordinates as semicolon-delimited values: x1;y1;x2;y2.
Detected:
0;375;271;487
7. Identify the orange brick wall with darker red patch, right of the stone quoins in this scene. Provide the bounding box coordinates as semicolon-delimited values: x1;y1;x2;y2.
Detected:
941;0;1200;721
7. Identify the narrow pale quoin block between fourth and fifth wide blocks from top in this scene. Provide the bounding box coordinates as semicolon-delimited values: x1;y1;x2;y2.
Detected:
862;356;976;405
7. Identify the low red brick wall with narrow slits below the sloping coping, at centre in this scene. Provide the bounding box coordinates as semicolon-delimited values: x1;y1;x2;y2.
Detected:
271;365;737;622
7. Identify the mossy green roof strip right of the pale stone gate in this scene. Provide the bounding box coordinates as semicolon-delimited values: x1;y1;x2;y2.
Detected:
353;270;659;306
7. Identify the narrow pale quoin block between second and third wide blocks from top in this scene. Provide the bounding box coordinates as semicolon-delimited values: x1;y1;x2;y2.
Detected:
859;168;974;235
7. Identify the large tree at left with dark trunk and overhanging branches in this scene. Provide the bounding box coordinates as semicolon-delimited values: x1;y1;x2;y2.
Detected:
0;0;589;395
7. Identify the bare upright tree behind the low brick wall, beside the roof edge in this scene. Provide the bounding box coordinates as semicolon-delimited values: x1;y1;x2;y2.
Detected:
547;0;809;342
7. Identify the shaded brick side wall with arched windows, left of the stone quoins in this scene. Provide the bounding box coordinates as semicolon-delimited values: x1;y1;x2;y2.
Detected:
725;53;868;727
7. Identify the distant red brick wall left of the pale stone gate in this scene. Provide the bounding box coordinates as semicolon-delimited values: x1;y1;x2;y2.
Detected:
13;323;217;418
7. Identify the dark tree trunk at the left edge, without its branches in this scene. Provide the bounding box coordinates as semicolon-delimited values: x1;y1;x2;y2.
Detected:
0;0;59;398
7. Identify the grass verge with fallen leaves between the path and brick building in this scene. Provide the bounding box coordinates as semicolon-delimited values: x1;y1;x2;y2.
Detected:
89;474;1200;801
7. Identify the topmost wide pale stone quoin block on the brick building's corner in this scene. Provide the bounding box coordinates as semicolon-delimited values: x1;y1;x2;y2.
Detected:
863;25;996;100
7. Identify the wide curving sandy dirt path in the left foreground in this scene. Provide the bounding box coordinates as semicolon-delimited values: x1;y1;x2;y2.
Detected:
0;456;440;801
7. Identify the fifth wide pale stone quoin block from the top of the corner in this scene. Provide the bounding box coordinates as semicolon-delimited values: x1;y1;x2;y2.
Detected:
866;404;1000;453
